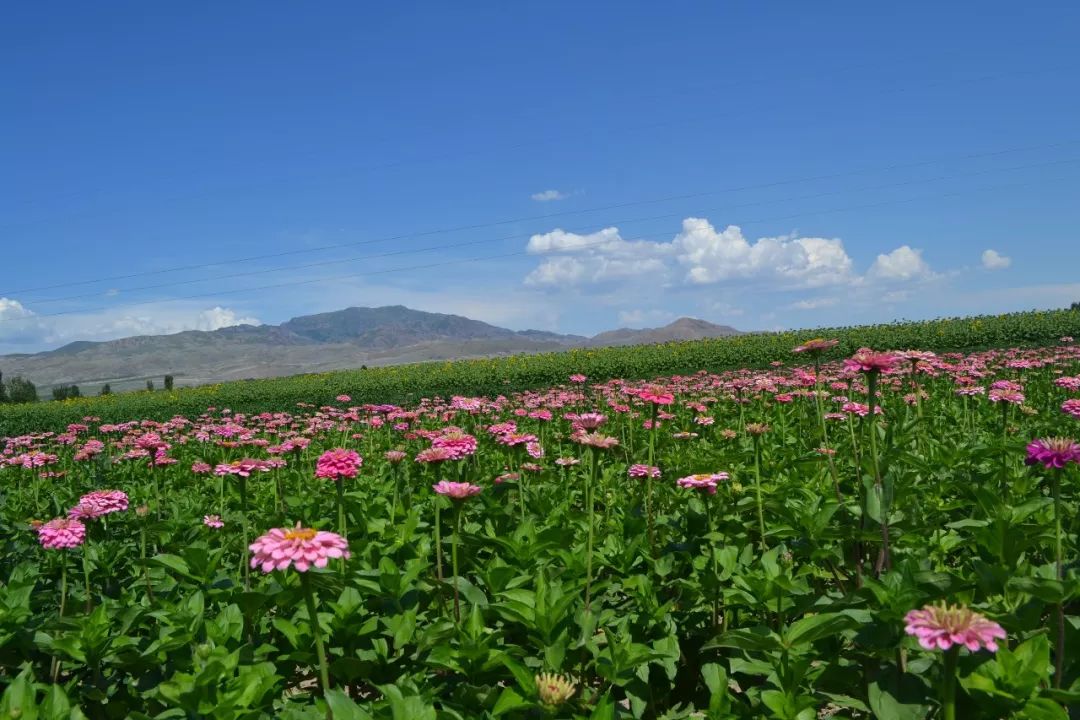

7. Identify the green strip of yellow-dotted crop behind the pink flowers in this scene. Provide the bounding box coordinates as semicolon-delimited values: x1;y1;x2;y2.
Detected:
0;310;1080;437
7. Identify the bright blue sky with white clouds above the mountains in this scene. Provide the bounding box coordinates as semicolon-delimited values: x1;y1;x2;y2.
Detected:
0;2;1080;352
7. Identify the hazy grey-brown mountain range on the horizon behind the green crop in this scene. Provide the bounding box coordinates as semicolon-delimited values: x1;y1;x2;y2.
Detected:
0;305;740;394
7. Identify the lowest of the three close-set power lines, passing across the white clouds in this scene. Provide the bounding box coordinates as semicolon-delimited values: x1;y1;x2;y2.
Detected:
0;170;1071;324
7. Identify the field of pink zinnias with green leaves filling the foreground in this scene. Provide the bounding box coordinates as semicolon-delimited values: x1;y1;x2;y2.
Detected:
0;338;1080;720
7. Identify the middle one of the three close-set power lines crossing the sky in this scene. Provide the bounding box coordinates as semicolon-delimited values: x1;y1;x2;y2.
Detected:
21;158;1080;305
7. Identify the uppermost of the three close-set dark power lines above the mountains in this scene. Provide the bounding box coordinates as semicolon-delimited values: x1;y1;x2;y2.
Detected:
0;139;1080;297
